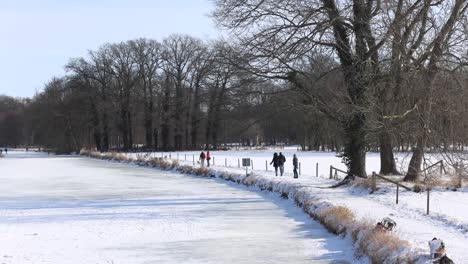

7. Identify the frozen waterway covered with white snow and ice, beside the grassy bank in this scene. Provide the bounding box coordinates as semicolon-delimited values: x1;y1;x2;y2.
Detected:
0;152;354;264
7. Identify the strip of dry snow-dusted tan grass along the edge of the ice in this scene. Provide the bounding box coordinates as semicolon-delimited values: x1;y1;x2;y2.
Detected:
82;151;422;263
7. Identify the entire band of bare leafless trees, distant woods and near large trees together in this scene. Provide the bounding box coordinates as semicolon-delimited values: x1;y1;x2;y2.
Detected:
0;0;468;180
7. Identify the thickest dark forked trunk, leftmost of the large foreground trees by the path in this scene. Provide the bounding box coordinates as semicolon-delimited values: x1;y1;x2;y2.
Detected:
323;0;370;178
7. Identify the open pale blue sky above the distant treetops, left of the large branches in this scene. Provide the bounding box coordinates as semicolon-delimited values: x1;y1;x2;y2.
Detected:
0;0;220;97
